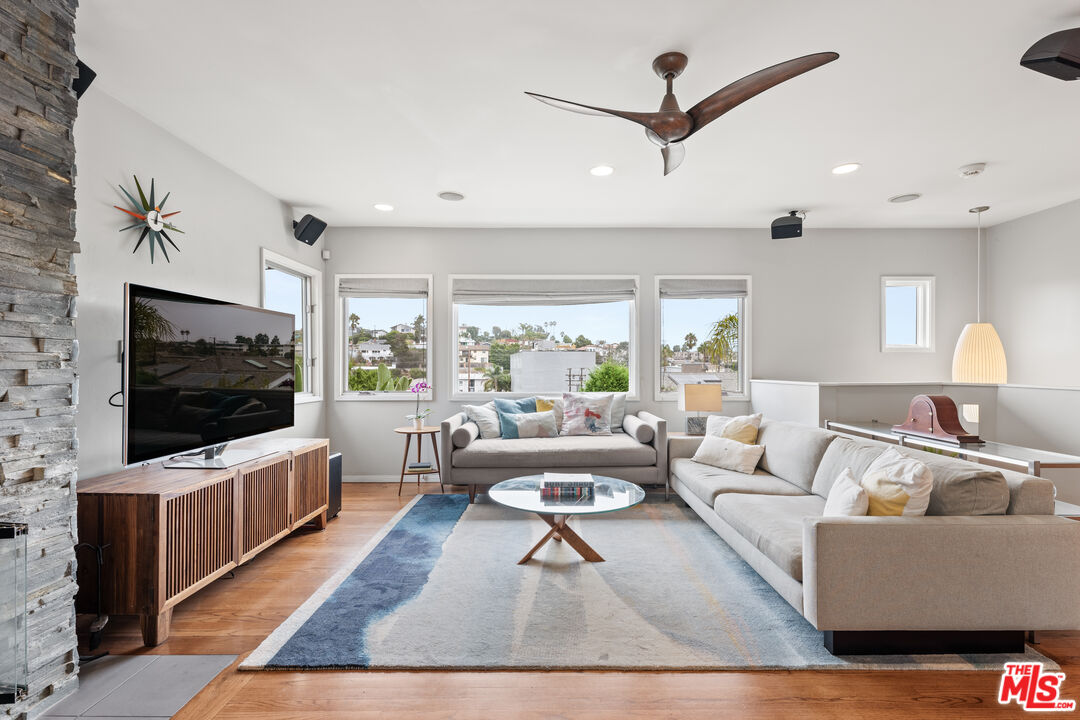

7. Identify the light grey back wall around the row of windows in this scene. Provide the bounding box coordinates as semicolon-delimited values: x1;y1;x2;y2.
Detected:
325;226;975;478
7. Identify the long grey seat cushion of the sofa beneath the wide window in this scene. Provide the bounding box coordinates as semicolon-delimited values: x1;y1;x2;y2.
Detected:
451;433;657;475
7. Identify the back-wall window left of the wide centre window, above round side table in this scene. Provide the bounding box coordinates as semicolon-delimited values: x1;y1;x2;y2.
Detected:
335;275;432;400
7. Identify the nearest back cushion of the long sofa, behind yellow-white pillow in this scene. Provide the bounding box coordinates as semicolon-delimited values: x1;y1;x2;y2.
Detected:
897;447;1009;515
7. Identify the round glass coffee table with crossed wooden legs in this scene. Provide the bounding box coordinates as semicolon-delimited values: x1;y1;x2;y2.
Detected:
487;475;645;565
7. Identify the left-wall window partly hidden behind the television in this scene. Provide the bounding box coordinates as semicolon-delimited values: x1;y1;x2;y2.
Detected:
262;248;323;403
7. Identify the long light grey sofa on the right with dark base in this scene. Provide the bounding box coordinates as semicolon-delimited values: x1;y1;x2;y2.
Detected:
670;420;1080;654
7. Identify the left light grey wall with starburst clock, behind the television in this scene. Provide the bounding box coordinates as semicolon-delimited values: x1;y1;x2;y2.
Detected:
75;87;325;477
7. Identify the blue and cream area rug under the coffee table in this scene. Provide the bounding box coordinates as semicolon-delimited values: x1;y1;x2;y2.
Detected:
241;494;1055;673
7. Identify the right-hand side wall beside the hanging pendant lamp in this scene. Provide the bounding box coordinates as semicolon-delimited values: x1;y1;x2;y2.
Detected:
984;201;1080;388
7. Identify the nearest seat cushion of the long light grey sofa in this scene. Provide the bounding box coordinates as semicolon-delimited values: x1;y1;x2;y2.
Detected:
713;493;825;583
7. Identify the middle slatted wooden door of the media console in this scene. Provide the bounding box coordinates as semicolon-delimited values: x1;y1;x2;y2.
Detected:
238;454;292;562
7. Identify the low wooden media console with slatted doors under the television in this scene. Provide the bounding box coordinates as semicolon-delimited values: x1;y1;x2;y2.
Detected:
78;438;329;646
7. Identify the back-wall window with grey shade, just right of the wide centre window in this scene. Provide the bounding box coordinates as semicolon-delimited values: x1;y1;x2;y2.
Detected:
654;275;751;400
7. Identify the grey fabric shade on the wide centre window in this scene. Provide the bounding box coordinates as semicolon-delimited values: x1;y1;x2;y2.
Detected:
451;276;637;305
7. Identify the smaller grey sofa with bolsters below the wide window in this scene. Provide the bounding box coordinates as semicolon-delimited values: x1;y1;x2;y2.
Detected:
438;412;667;500
